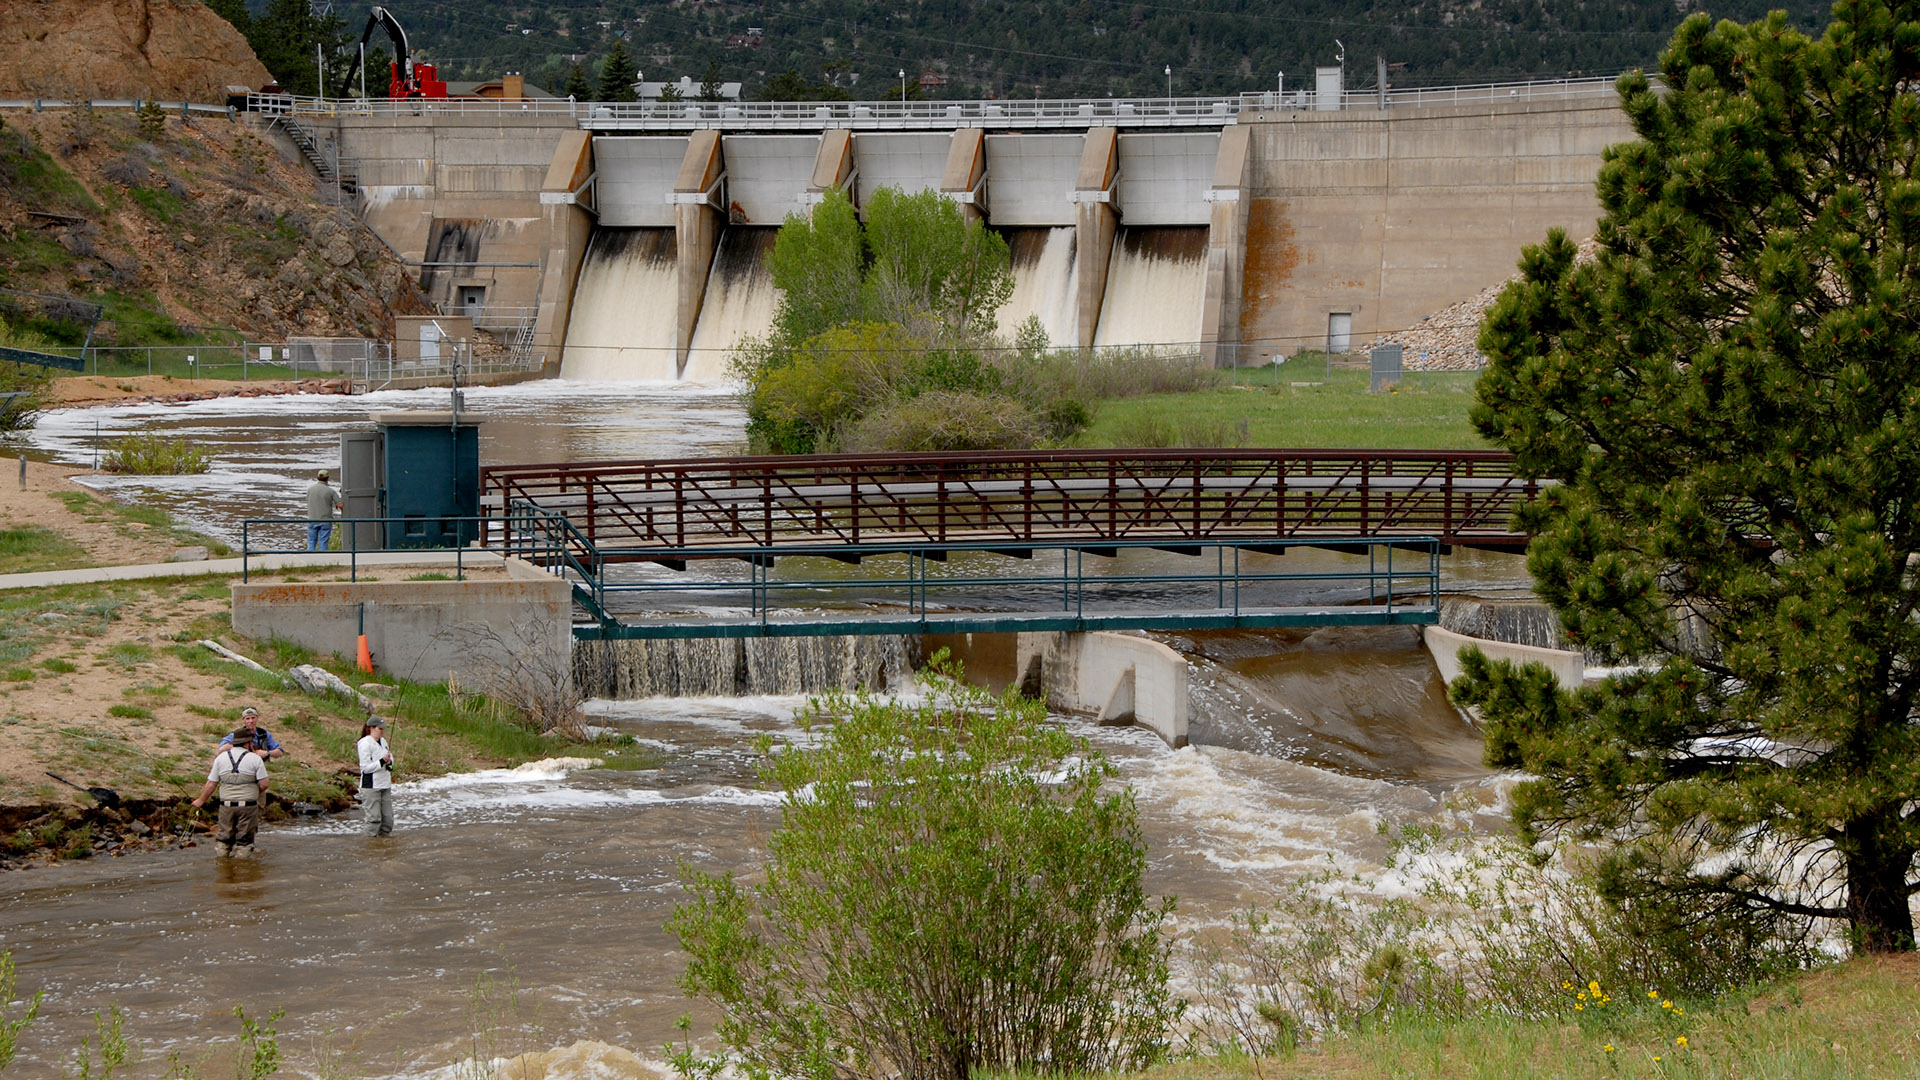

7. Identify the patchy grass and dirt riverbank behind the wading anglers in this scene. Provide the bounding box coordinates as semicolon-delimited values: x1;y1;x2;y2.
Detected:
0;571;657;863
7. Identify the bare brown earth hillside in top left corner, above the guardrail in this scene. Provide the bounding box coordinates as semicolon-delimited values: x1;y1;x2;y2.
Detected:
0;0;269;102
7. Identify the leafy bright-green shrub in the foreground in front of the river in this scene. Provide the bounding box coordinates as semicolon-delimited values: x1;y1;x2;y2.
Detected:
668;664;1185;1080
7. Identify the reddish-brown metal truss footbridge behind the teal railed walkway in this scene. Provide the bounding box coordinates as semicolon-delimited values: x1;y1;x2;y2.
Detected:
482;450;1542;565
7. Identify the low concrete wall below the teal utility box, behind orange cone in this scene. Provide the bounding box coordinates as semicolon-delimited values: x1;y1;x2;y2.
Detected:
232;559;572;684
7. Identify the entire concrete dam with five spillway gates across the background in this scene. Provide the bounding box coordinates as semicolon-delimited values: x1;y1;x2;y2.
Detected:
311;81;1632;382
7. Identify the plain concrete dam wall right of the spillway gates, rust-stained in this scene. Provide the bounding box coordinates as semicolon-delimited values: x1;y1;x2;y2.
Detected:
1240;94;1634;351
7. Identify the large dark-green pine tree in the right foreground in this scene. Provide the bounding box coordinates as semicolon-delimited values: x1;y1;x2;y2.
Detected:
1455;0;1920;951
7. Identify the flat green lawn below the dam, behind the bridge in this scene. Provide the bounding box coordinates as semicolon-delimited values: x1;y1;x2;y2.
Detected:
1073;361;1488;450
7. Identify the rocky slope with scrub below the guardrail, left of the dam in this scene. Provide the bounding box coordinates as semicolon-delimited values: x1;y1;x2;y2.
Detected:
0;104;426;344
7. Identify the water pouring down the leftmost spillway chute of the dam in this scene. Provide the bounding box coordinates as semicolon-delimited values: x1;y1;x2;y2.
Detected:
561;229;680;382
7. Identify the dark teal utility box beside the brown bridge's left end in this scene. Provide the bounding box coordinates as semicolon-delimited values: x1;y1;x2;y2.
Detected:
366;411;480;548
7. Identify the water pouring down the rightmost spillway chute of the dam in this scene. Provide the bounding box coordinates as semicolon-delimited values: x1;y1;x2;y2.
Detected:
1092;229;1206;346
